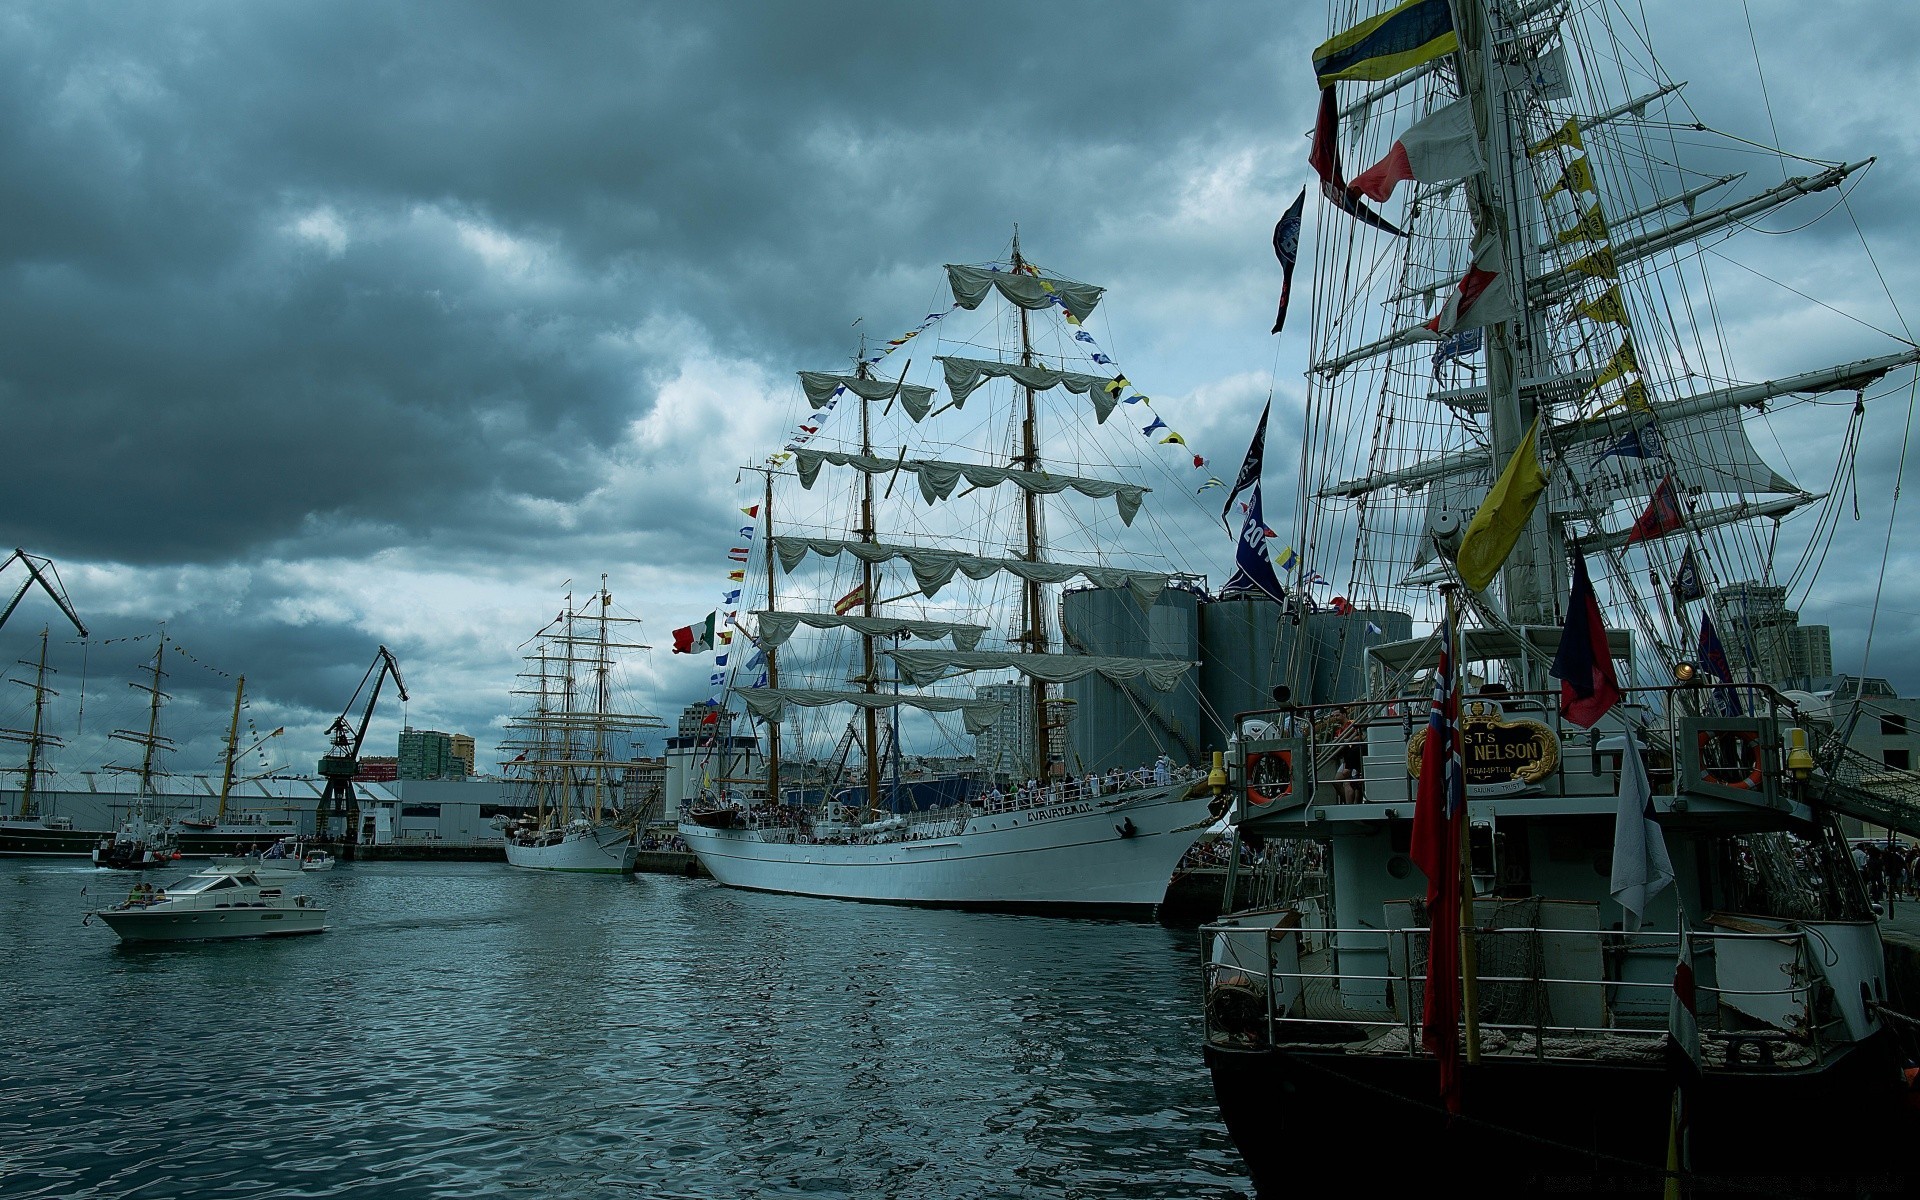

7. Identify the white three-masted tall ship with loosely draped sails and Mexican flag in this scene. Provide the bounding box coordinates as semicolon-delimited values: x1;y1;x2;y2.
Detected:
680;238;1215;912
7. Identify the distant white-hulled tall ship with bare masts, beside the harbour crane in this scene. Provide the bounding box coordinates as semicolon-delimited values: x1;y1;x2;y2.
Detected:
503;576;664;874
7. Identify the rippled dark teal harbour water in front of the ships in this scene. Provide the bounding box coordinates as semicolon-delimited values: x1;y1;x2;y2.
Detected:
0;860;1252;1200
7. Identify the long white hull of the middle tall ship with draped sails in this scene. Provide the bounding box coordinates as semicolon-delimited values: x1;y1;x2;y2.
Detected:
680;783;1210;914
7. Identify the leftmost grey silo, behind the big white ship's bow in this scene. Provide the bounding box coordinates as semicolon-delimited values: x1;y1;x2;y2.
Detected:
1060;588;1213;774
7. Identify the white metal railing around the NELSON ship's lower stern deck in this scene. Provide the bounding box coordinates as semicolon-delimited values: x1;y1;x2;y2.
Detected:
1200;910;1820;1068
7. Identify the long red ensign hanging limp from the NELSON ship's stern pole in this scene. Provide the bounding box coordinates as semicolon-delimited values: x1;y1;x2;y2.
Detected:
1411;603;1467;1112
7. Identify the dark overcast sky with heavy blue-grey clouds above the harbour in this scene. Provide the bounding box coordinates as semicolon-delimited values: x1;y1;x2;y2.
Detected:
0;0;1920;783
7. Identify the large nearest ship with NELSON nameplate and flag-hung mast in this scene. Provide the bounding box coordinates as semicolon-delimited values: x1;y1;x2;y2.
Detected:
1206;0;1920;1196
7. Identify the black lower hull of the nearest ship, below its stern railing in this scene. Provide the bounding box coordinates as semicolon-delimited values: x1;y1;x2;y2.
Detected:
1206;1035;1920;1200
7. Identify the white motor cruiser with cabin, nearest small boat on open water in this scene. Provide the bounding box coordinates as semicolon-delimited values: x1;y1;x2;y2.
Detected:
86;866;326;943
